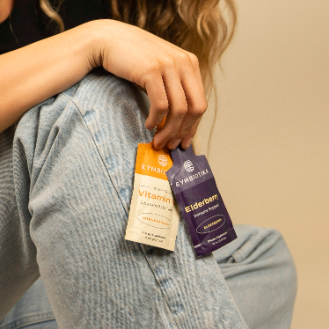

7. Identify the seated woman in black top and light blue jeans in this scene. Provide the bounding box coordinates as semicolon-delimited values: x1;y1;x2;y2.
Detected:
0;0;296;328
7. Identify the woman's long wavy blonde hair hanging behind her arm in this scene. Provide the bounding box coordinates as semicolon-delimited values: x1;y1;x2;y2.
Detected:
39;0;237;150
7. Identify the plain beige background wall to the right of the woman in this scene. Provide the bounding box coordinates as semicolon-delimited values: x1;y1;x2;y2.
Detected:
200;0;329;329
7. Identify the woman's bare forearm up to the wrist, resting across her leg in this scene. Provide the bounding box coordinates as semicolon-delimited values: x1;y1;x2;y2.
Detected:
0;23;97;132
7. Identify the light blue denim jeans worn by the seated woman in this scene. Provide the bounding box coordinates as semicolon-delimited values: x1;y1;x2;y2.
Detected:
0;71;297;329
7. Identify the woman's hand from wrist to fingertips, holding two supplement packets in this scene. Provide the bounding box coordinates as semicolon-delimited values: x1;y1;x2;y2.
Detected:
90;20;207;149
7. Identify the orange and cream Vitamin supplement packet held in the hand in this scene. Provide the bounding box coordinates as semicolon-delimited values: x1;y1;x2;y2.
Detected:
125;143;179;251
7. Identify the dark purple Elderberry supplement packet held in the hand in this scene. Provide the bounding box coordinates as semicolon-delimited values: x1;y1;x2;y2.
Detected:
166;146;237;257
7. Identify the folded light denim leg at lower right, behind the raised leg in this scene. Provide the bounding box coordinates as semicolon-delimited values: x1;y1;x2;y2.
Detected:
214;225;297;329
